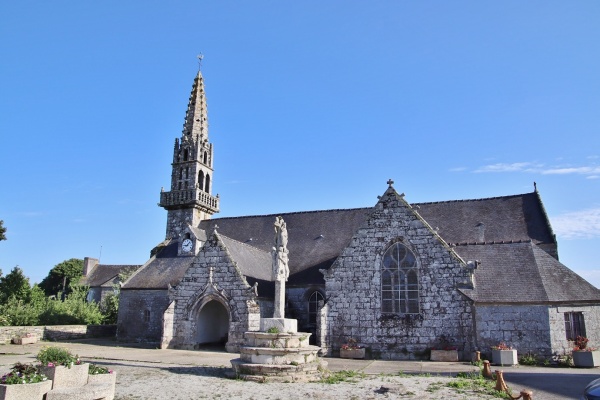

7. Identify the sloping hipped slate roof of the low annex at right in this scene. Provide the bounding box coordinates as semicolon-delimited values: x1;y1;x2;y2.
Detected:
454;241;600;304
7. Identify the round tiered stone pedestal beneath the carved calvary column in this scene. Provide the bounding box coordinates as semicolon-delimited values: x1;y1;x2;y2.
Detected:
231;318;327;382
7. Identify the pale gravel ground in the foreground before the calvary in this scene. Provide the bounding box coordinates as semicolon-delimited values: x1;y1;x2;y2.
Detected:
98;361;504;400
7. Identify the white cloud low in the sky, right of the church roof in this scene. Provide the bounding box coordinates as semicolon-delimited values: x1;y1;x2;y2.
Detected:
550;208;600;239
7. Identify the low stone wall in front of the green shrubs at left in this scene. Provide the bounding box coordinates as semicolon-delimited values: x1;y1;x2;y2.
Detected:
0;325;117;344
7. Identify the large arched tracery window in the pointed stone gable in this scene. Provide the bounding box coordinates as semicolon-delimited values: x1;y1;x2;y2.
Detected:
381;243;419;314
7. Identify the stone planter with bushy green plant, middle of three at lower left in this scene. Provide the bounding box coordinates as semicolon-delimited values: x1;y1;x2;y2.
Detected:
36;346;89;389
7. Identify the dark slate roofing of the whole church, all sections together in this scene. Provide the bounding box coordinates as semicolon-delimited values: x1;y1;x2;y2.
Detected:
125;192;600;303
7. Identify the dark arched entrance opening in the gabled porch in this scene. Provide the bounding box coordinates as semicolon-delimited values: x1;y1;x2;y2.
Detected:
196;300;229;346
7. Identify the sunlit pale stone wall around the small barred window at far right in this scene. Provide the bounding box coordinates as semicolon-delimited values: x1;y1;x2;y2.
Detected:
547;304;600;355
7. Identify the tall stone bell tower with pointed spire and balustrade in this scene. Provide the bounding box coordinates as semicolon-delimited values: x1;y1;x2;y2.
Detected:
158;71;219;239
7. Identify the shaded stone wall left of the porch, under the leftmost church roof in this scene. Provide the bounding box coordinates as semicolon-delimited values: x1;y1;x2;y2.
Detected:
117;289;169;343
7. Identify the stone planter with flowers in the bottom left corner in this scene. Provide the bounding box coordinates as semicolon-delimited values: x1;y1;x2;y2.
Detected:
0;363;52;400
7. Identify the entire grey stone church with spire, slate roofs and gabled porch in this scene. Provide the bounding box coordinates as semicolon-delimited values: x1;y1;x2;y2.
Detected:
118;72;600;359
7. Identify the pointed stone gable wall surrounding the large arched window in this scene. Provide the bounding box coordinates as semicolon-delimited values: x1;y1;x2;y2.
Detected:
321;187;473;359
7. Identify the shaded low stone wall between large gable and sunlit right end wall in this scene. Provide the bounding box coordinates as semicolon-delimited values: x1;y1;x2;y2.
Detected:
474;304;552;356
